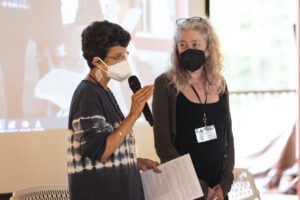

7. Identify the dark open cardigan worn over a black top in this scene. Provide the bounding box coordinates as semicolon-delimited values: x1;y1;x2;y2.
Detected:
152;73;234;197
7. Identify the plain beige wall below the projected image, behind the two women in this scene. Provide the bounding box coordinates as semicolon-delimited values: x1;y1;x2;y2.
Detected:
0;125;159;193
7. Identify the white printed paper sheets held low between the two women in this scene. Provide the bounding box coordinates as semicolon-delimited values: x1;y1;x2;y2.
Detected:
141;154;203;200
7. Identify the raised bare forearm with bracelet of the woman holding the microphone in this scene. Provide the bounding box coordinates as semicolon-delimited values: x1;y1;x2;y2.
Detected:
100;114;138;162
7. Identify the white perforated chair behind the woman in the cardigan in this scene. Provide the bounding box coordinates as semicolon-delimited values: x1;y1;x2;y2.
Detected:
228;168;261;200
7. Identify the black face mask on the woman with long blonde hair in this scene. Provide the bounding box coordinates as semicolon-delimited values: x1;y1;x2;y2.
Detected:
179;49;205;72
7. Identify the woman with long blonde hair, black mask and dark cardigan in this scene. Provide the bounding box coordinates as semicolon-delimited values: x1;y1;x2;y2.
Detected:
152;17;234;200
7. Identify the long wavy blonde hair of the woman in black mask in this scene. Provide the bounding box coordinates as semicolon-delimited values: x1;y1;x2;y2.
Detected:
168;17;225;94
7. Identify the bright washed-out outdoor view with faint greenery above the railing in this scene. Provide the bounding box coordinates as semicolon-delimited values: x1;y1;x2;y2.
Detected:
210;0;297;91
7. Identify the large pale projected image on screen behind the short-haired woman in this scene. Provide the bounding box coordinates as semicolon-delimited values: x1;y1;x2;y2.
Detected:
0;0;187;132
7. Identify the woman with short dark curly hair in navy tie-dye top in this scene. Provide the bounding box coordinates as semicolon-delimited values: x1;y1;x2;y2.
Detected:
68;21;160;200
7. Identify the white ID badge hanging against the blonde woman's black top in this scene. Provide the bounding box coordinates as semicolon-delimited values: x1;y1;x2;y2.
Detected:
195;125;217;143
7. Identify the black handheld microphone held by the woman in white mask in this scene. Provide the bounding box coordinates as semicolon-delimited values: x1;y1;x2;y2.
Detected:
128;75;153;126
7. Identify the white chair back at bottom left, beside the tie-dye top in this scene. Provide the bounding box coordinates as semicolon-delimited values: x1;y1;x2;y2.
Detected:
10;185;69;200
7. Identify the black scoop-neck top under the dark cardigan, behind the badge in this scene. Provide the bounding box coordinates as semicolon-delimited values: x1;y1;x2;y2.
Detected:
175;93;226;187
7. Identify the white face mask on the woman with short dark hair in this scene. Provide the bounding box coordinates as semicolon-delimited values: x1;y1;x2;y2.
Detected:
97;58;131;82
